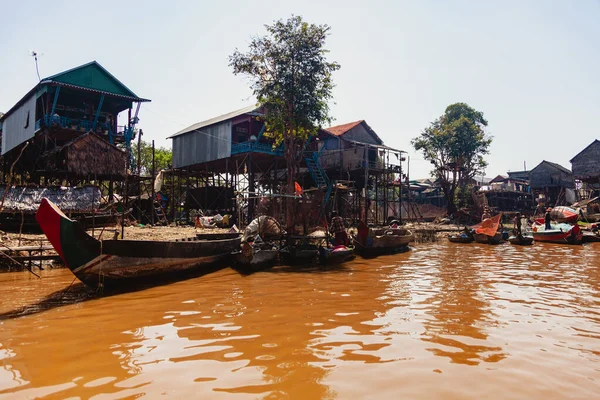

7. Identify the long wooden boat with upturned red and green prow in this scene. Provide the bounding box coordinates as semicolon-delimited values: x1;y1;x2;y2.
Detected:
36;198;240;288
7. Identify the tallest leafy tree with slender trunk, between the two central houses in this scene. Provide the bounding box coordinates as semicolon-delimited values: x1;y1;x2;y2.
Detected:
229;16;339;226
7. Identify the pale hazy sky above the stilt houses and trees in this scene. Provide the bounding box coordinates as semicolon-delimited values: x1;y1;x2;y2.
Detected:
0;0;600;179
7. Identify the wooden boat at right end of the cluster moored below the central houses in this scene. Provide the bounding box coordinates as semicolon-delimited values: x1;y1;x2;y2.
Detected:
353;225;415;257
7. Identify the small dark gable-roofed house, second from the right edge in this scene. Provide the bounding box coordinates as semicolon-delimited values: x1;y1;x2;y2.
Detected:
529;160;577;206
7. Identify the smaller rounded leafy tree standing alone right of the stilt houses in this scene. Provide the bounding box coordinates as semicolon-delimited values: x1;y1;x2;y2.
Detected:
411;103;492;214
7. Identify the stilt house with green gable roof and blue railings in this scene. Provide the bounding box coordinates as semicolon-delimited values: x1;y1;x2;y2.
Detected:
0;61;149;184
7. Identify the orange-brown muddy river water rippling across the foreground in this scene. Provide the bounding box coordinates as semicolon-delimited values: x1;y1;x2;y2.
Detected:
0;243;600;399
